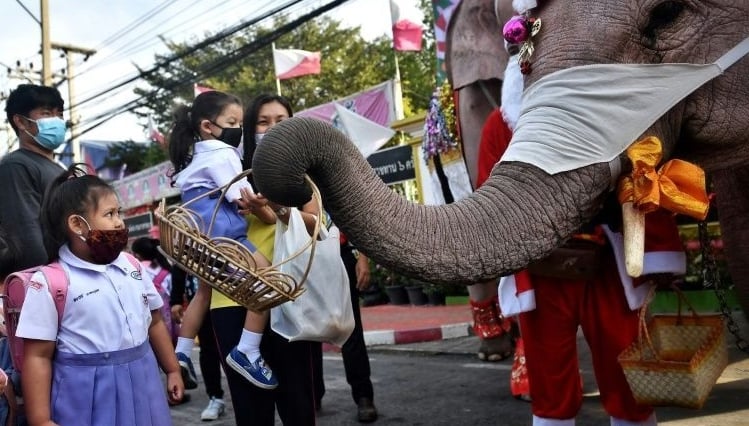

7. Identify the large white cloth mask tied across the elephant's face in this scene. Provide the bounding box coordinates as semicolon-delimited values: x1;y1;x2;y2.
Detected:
500;38;749;174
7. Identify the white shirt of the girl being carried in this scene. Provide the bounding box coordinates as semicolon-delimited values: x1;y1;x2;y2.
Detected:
175;139;254;202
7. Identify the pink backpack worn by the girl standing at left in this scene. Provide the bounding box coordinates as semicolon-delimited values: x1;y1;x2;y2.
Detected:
3;262;69;373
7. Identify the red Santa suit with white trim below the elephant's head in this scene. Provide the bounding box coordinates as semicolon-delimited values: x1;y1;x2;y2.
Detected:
478;98;686;425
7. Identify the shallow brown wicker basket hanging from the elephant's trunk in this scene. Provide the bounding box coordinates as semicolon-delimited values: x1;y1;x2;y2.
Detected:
154;170;322;311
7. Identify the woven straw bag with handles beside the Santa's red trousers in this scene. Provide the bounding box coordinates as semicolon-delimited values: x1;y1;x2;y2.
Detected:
619;287;728;408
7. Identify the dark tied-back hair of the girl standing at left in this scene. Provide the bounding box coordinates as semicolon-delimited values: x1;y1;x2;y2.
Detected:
39;163;116;262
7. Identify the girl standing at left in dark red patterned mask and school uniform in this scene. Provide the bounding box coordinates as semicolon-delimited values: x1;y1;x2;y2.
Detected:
17;165;184;426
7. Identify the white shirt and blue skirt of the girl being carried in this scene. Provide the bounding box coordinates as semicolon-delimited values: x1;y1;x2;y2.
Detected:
176;140;256;252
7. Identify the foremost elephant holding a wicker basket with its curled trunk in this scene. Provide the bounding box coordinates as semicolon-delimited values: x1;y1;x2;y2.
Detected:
253;0;749;322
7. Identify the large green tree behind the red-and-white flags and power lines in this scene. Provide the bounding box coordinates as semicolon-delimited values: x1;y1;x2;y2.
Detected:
136;4;435;129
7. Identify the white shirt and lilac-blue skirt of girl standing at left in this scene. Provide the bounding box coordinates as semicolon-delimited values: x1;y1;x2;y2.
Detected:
17;246;172;426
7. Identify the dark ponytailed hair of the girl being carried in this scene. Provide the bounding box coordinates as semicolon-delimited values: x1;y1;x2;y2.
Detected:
168;90;242;181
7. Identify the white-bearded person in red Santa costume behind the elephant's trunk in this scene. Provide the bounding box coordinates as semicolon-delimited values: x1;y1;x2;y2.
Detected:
490;2;686;426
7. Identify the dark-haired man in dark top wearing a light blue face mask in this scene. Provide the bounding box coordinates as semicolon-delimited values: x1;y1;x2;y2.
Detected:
0;84;66;271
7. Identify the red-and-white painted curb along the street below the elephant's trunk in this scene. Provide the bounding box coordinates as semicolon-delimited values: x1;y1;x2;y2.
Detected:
323;322;471;352
